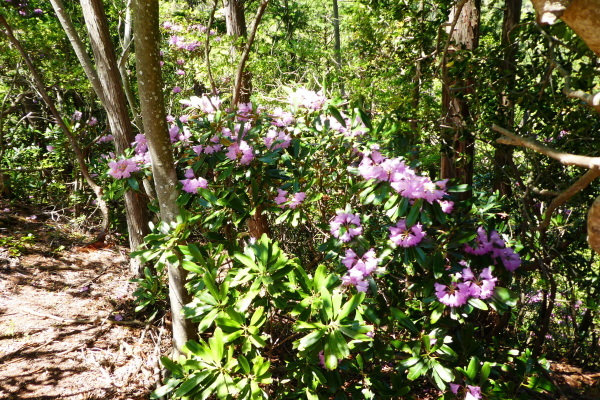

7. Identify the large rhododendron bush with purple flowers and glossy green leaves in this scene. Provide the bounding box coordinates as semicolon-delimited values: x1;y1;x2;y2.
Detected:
108;89;543;399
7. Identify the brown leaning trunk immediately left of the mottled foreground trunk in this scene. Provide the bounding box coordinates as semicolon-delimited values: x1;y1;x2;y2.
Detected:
81;0;150;275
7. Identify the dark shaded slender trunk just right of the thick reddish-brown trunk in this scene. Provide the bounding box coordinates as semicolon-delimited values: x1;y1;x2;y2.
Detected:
493;0;522;197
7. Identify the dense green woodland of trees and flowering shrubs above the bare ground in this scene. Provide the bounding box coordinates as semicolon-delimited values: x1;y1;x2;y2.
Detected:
0;0;600;399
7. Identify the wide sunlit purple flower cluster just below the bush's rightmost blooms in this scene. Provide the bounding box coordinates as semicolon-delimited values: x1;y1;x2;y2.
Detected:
434;267;498;307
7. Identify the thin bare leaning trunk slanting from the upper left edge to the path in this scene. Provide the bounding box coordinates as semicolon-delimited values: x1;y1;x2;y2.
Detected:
0;14;110;241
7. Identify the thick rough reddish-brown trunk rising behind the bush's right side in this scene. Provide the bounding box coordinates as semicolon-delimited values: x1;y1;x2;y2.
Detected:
440;0;481;200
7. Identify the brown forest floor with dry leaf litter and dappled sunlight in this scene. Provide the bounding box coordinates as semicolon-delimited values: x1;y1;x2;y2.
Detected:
0;199;600;400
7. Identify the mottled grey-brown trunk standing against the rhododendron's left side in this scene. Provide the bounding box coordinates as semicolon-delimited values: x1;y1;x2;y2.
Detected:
133;0;196;357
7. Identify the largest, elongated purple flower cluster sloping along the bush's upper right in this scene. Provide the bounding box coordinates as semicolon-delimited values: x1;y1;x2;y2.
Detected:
358;149;453;206
